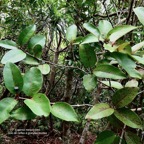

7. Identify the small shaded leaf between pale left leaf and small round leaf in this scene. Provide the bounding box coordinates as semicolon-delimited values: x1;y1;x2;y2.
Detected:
23;54;39;65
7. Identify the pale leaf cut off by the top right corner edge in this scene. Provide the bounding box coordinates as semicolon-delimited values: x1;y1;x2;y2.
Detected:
134;7;144;25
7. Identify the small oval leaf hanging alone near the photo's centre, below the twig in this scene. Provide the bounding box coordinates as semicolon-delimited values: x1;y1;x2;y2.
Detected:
83;74;97;92
